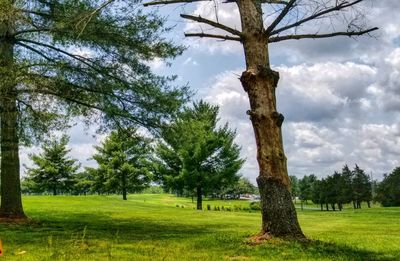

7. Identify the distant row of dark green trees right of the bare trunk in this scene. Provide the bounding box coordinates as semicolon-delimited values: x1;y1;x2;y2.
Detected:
290;165;400;211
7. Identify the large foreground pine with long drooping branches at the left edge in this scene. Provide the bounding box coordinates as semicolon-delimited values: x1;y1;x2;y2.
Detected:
0;0;186;218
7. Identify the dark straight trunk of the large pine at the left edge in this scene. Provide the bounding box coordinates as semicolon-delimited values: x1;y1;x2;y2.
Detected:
0;15;25;219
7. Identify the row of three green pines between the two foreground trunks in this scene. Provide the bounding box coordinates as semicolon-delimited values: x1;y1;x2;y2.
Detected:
22;101;257;209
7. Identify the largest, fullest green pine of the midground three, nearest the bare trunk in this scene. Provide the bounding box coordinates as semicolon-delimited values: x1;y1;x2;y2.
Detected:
156;101;244;209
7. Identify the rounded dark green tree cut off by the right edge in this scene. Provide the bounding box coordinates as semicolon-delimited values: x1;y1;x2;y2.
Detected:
375;167;400;207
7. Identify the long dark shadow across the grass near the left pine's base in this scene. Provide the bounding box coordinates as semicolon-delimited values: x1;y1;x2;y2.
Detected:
0;210;217;241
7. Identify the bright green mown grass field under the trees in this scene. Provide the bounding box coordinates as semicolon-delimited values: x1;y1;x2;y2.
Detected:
0;194;400;261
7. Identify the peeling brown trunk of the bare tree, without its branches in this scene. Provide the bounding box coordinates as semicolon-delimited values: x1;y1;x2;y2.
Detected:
237;0;304;238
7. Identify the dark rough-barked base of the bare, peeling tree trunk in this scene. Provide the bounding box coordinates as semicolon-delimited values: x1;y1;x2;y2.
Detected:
257;176;306;240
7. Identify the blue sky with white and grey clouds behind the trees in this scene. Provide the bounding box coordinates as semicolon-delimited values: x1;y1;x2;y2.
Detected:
21;0;400;181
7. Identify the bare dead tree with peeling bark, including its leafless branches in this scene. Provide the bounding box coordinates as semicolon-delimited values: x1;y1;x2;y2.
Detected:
145;0;378;238
